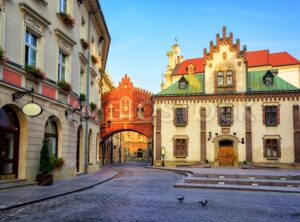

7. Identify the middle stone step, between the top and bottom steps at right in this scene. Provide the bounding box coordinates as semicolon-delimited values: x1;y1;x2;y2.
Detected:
184;177;300;187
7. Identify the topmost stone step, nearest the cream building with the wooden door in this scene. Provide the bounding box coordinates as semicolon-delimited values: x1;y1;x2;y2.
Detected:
194;173;300;180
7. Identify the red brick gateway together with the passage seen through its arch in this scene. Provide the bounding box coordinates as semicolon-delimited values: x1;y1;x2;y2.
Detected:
100;75;153;163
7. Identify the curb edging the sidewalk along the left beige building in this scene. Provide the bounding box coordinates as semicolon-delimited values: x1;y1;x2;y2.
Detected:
0;170;119;212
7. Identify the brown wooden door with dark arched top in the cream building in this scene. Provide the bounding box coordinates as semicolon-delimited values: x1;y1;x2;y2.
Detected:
218;140;234;166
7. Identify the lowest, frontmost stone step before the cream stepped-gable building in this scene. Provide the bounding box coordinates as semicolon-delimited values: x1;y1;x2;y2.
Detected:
174;182;300;193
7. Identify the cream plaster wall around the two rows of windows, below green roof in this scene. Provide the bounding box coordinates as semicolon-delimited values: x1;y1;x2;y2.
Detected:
154;96;299;163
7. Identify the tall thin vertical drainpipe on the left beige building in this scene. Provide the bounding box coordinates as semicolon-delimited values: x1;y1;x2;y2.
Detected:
84;12;92;173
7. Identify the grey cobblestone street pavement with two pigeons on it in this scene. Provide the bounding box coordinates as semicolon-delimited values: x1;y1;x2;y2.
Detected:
0;161;300;222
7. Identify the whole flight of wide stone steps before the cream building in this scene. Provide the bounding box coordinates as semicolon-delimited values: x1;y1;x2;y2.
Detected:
174;174;300;193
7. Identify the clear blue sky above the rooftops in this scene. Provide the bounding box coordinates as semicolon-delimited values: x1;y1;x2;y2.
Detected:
100;0;300;93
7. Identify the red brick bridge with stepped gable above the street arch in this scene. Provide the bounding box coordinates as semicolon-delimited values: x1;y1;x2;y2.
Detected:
101;75;153;141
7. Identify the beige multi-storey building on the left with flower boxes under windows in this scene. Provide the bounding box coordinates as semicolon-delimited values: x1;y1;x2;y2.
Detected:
0;0;110;181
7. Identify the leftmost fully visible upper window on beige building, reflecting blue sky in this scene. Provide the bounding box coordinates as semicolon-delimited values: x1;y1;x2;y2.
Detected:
25;31;37;67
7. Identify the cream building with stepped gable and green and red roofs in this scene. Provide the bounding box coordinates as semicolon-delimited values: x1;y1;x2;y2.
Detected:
153;27;300;166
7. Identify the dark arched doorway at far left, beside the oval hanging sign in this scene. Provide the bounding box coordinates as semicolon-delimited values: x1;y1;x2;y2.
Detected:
0;106;20;179
